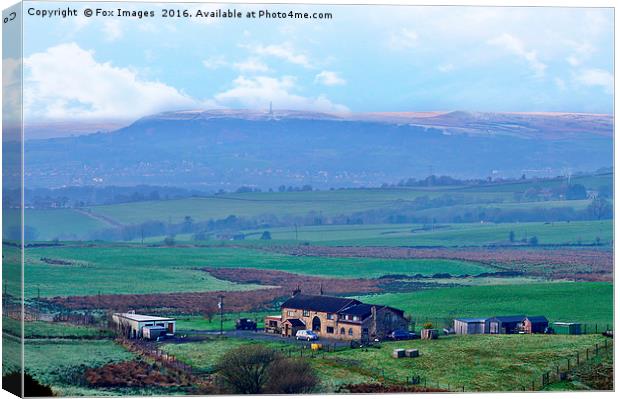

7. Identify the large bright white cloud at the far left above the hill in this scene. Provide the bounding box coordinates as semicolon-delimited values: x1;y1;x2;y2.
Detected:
24;43;204;120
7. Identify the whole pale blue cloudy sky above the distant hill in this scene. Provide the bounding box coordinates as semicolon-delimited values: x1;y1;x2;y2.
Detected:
14;3;613;122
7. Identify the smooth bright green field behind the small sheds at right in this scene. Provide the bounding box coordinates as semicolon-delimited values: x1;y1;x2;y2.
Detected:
358;283;613;328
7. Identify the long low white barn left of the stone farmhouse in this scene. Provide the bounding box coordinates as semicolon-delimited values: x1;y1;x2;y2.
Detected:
112;312;176;339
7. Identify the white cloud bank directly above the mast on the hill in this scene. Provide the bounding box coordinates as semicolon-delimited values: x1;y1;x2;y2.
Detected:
214;76;349;113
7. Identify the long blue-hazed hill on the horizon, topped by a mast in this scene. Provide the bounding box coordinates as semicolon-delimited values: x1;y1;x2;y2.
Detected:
25;110;613;190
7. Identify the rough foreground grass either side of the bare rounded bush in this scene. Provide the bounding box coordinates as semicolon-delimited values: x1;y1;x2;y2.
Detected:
164;335;603;392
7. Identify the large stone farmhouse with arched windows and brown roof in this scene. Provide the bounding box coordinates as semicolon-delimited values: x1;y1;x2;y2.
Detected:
265;291;409;341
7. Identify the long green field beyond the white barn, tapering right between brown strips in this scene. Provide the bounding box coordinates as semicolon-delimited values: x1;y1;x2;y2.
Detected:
17;244;492;298
